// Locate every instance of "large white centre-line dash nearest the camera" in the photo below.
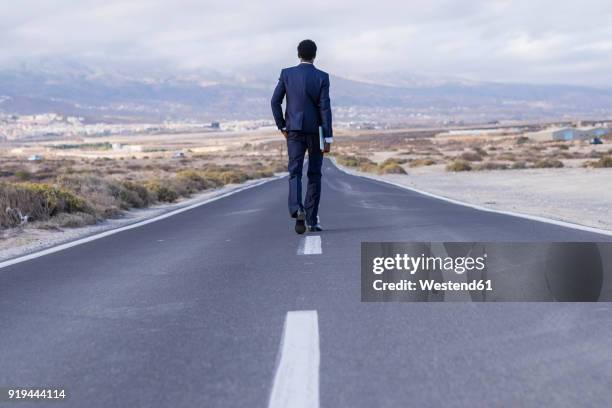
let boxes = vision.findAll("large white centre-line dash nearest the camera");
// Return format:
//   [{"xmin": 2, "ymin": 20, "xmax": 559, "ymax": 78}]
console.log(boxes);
[{"xmin": 268, "ymin": 310, "xmax": 321, "ymax": 408}]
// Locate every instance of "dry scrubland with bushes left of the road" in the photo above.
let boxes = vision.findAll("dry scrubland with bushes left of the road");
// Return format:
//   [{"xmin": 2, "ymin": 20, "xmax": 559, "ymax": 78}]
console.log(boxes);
[{"xmin": 0, "ymin": 132, "xmax": 286, "ymax": 249}]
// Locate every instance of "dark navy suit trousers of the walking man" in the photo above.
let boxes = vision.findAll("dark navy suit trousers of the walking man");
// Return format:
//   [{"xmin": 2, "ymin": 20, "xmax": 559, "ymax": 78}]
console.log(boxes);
[{"xmin": 287, "ymin": 131, "xmax": 323, "ymax": 225}]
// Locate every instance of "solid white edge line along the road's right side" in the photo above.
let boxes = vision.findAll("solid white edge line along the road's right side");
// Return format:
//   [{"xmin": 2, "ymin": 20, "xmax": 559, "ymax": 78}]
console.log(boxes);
[{"xmin": 330, "ymin": 158, "xmax": 612, "ymax": 237}]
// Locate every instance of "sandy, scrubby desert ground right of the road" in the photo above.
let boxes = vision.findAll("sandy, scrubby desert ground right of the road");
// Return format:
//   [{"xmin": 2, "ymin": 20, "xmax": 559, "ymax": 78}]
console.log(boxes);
[{"xmin": 335, "ymin": 130, "xmax": 612, "ymax": 230}]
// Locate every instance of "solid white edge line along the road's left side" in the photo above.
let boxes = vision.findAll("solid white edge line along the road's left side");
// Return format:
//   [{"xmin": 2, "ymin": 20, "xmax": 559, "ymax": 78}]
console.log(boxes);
[{"xmin": 0, "ymin": 175, "xmax": 286, "ymax": 269}]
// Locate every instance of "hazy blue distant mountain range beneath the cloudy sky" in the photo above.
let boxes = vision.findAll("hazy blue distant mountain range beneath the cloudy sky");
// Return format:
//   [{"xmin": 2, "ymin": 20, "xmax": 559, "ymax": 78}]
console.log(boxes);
[{"xmin": 0, "ymin": 60, "xmax": 612, "ymax": 122}]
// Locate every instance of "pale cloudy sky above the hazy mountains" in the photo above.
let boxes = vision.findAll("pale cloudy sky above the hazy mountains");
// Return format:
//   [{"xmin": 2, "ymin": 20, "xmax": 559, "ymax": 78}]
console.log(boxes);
[{"xmin": 0, "ymin": 0, "xmax": 612, "ymax": 86}]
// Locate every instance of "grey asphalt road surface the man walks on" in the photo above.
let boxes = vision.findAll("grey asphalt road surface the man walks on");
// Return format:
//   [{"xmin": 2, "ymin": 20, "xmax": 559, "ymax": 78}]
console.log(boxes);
[{"xmin": 0, "ymin": 161, "xmax": 612, "ymax": 407}]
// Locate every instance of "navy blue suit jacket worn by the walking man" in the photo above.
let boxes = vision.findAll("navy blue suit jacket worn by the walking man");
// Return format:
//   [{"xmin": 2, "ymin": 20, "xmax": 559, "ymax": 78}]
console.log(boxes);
[{"xmin": 271, "ymin": 63, "xmax": 333, "ymax": 138}]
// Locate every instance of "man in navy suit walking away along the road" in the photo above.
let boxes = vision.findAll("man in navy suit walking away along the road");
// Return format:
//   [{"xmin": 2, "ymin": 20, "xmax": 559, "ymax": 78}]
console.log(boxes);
[{"xmin": 271, "ymin": 40, "xmax": 333, "ymax": 234}]
